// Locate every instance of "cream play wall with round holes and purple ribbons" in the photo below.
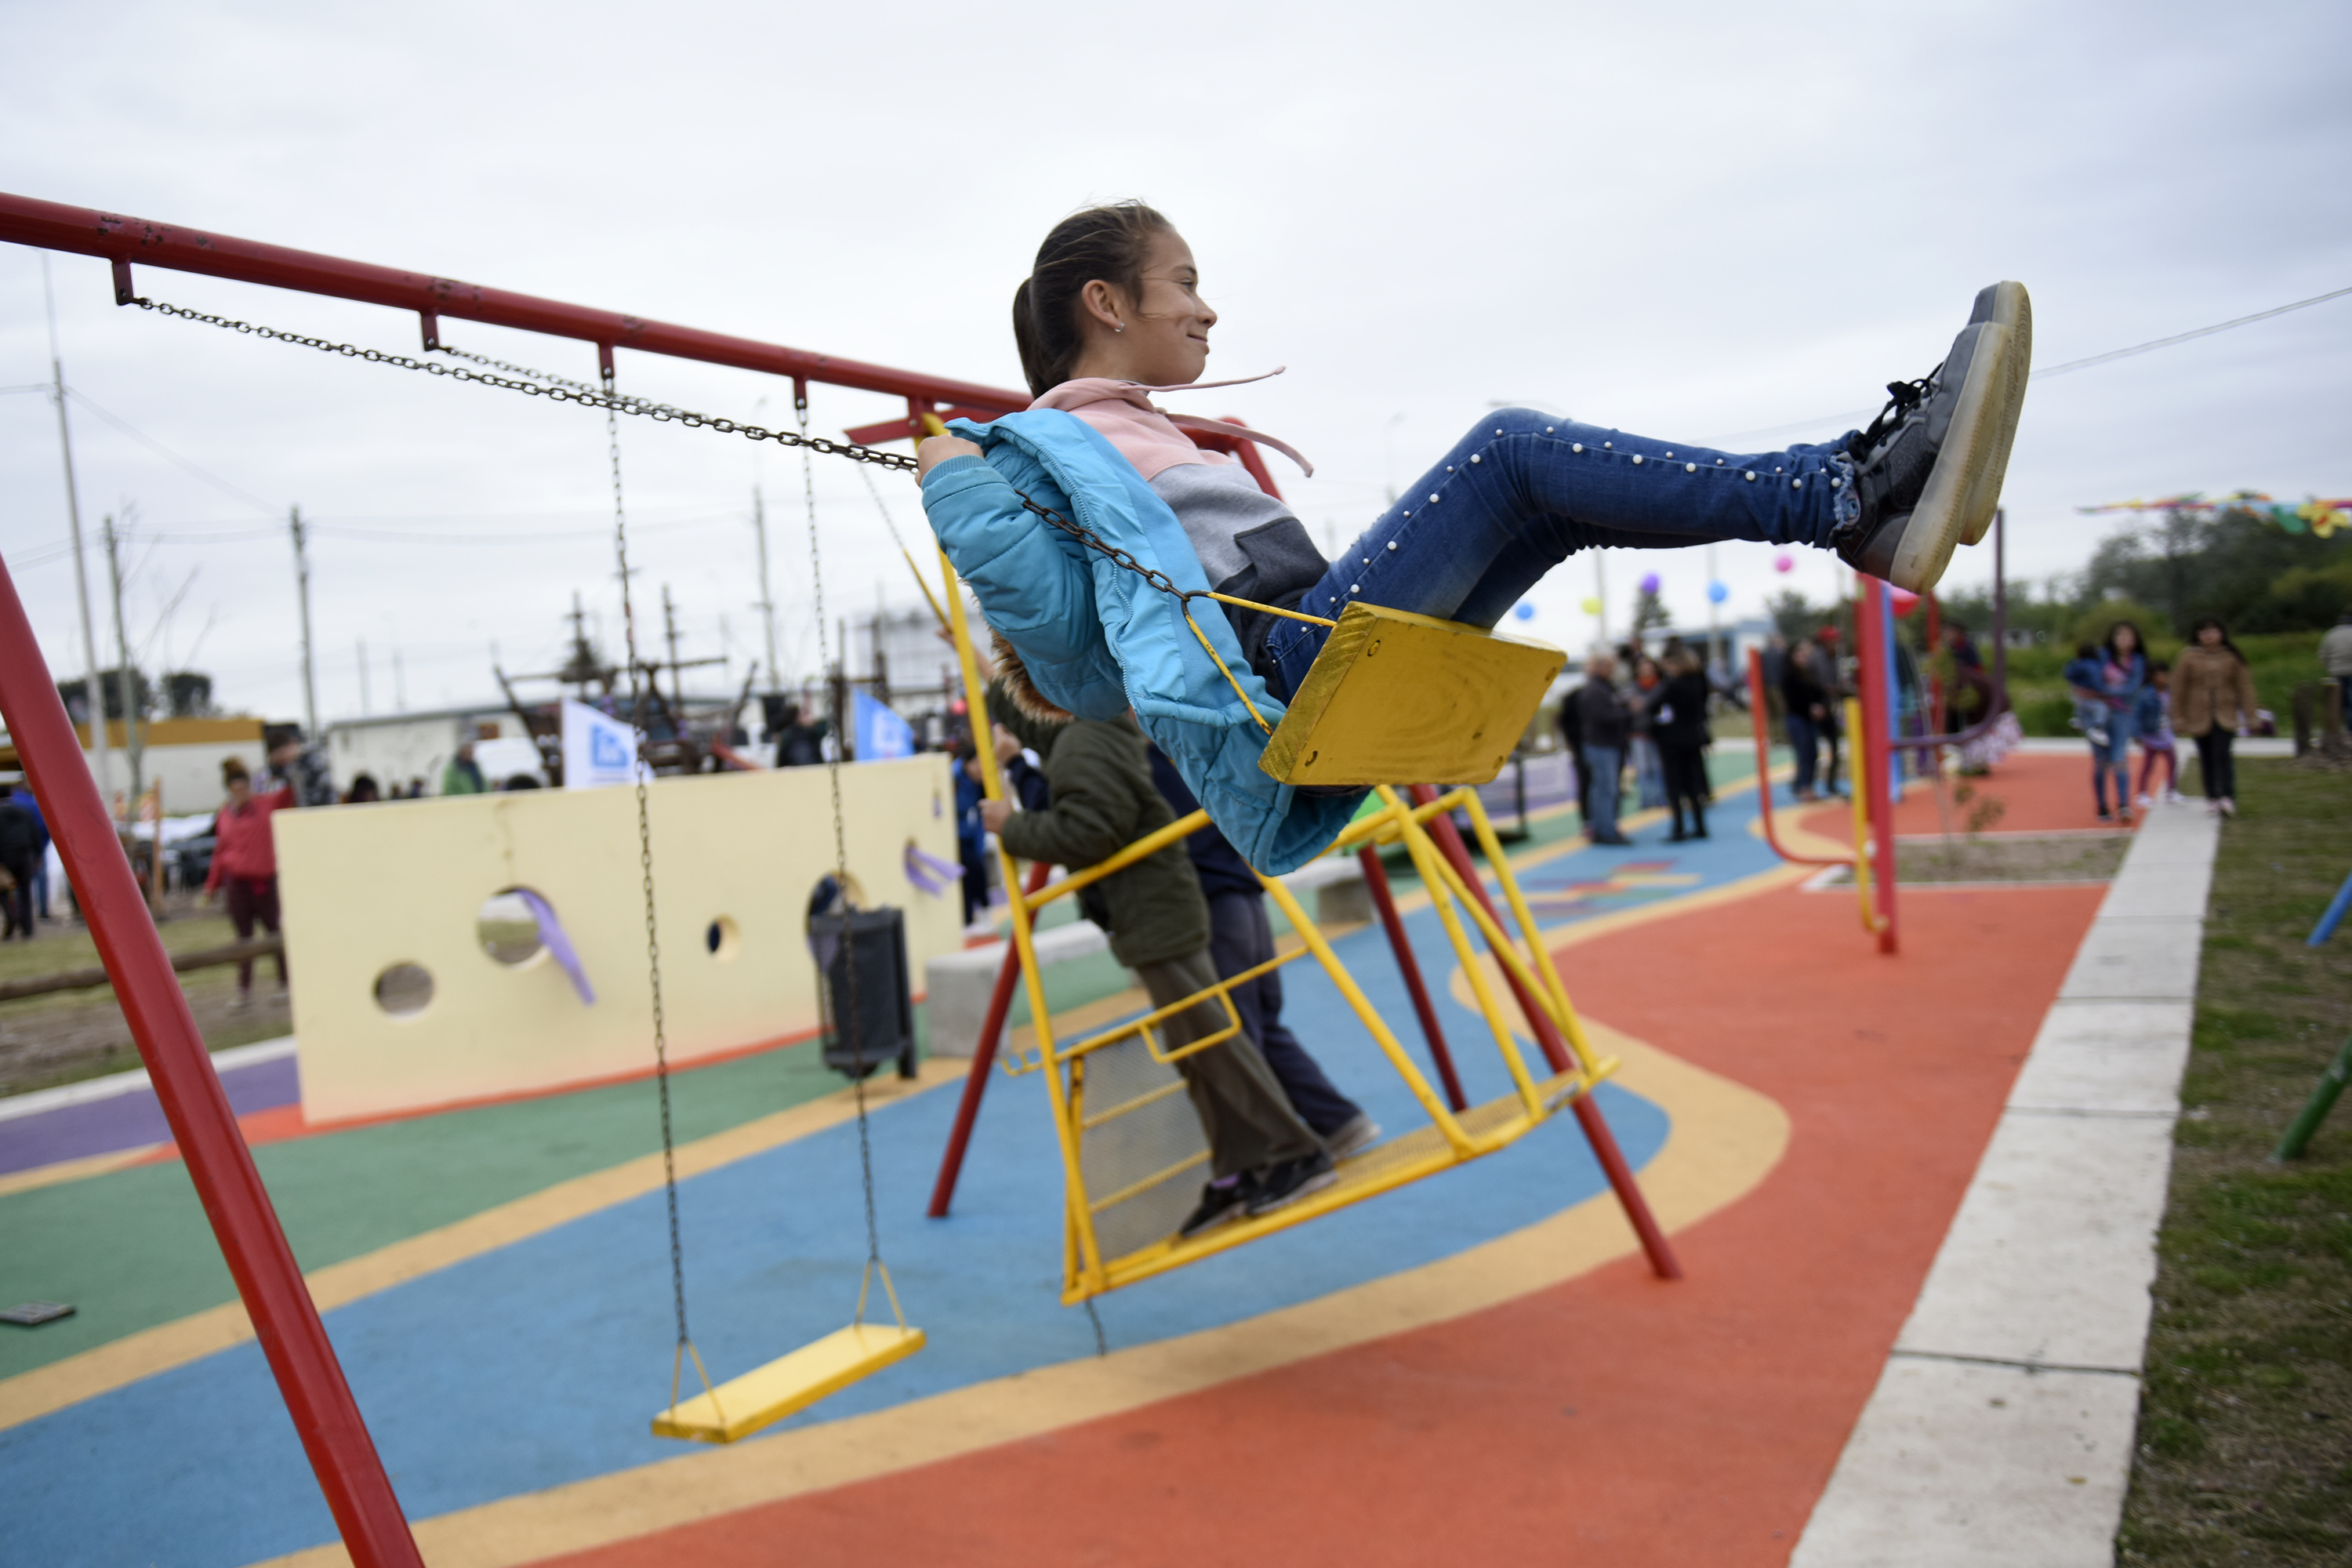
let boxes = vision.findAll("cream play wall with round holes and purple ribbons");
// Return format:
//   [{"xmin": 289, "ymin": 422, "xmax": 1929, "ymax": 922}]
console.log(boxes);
[{"xmin": 275, "ymin": 755, "xmax": 962, "ymax": 1123}]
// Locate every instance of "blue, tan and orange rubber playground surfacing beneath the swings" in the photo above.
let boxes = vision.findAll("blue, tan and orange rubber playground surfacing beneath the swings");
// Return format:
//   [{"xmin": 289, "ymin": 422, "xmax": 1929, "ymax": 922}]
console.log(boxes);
[{"xmin": 0, "ymin": 760, "xmax": 2098, "ymax": 1563}]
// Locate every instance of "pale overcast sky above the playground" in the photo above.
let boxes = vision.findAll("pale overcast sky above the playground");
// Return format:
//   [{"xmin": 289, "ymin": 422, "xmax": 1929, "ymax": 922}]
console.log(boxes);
[{"xmin": 0, "ymin": 0, "xmax": 2352, "ymax": 717}]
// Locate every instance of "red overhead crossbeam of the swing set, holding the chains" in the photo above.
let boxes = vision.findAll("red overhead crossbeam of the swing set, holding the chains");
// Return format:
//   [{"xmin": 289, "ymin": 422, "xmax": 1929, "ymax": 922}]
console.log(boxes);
[{"xmin": 0, "ymin": 191, "xmax": 1030, "ymax": 414}]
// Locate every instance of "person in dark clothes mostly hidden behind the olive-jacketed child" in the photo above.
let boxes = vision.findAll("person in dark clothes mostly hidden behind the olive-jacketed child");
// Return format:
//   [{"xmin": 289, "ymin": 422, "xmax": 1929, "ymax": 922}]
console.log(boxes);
[{"xmin": 1150, "ymin": 746, "xmax": 1381, "ymax": 1161}]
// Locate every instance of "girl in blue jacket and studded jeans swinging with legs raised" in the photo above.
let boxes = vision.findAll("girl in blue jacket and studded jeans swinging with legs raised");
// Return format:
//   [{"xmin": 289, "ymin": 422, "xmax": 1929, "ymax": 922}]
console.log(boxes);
[{"xmin": 917, "ymin": 202, "xmax": 2032, "ymax": 874}]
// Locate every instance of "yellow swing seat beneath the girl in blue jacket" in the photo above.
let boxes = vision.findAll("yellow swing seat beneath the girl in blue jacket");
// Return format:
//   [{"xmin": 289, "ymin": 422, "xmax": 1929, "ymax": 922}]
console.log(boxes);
[{"xmin": 1258, "ymin": 604, "xmax": 1569, "ymax": 785}]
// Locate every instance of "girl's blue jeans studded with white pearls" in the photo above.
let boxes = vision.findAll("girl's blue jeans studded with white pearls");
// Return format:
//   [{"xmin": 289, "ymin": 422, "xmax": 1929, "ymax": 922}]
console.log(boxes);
[{"xmin": 1261, "ymin": 409, "xmax": 1860, "ymax": 699}]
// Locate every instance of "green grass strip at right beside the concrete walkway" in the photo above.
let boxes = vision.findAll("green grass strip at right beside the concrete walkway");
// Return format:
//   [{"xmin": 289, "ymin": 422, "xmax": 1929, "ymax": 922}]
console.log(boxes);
[{"xmin": 2117, "ymin": 760, "xmax": 2352, "ymax": 1566}]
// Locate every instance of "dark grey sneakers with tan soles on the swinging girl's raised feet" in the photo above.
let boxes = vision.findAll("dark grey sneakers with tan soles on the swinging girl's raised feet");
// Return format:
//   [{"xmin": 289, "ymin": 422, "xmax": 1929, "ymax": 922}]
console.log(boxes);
[{"xmin": 1830, "ymin": 285, "xmax": 2032, "ymax": 593}]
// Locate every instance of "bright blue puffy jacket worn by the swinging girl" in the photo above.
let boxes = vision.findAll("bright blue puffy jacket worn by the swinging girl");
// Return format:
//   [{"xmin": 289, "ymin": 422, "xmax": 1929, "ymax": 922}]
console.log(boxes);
[{"xmin": 922, "ymin": 409, "xmax": 1362, "ymax": 877}]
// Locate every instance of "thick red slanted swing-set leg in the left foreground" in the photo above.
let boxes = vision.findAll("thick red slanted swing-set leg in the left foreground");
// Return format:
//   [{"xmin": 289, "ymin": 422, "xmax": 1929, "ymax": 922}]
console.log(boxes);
[{"xmin": 0, "ymin": 562, "xmax": 423, "ymax": 1568}]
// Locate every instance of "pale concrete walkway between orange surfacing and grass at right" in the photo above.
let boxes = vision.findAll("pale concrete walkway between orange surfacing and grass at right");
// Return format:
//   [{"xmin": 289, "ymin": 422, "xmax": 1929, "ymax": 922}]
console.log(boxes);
[{"xmin": 1790, "ymin": 804, "xmax": 2218, "ymax": 1568}]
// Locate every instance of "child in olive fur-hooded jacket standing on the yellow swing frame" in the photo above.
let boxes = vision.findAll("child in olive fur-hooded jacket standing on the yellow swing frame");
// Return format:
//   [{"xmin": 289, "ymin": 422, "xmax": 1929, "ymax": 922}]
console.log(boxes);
[{"xmin": 981, "ymin": 670, "xmax": 1334, "ymax": 1236}]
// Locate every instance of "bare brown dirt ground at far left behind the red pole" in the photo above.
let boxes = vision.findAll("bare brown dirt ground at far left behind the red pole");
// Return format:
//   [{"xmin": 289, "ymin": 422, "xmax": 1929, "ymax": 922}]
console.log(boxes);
[{"xmin": 0, "ymin": 900, "xmax": 294, "ymax": 1095}]
